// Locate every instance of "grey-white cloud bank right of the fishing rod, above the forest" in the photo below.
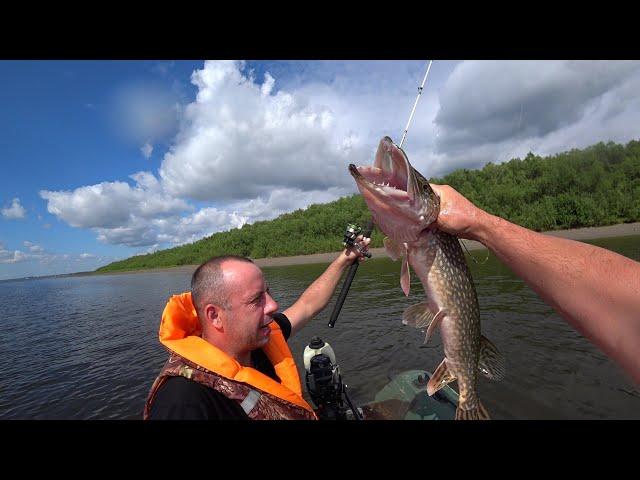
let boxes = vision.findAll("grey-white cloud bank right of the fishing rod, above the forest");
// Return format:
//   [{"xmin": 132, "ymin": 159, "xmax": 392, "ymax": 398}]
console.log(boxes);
[{"xmin": 434, "ymin": 60, "xmax": 640, "ymax": 173}]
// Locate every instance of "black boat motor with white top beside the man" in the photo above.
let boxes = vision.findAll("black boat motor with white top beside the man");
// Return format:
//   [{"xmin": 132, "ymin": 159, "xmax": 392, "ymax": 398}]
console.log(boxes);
[{"xmin": 304, "ymin": 337, "xmax": 363, "ymax": 420}]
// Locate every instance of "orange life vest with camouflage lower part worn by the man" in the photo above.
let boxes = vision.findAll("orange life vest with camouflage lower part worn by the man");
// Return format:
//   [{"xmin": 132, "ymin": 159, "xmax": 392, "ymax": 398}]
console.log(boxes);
[{"xmin": 145, "ymin": 292, "xmax": 316, "ymax": 418}]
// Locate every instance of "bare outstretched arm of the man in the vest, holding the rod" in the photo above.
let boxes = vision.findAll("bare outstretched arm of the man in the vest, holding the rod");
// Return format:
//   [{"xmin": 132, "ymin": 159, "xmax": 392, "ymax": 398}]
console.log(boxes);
[{"xmin": 283, "ymin": 236, "xmax": 371, "ymax": 336}]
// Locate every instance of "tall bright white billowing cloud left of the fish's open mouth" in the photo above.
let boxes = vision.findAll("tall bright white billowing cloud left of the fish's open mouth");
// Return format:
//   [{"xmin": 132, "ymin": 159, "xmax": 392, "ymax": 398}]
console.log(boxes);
[{"xmin": 160, "ymin": 61, "xmax": 370, "ymax": 200}]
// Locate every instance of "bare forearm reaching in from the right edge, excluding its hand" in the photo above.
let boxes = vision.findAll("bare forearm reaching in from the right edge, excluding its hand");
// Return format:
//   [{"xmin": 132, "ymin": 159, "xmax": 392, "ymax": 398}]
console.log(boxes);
[{"xmin": 473, "ymin": 214, "xmax": 640, "ymax": 383}]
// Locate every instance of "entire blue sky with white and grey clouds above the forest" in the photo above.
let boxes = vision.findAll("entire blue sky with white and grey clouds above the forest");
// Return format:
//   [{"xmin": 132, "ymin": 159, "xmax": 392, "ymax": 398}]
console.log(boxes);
[{"xmin": 0, "ymin": 60, "xmax": 640, "ymax": 280}]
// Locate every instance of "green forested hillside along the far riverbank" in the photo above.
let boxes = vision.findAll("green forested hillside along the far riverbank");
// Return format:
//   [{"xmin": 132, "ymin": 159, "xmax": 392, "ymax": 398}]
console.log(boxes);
[{"xmin": 97, "ymin": 141, "xmax": 640, "ymax": 272}]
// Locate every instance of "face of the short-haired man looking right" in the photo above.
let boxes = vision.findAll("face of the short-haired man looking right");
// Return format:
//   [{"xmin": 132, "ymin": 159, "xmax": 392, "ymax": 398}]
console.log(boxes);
[{"xmin": 221, "ymin": 261, "xmax": 278, "ymax": 352}]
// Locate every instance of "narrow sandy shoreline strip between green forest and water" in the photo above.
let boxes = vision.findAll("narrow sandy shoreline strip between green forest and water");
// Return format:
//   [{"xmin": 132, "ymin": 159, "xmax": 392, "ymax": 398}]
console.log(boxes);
[{"xmin": 63, "ymin": 222, "xmax": 640, "ymax": 278}]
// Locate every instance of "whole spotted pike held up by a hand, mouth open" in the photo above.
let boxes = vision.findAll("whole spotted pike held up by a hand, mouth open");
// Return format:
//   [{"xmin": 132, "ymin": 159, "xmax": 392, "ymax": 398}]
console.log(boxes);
[{"xmin": 349, "ymin": 137, "xmax": 505, "ymax": 420}]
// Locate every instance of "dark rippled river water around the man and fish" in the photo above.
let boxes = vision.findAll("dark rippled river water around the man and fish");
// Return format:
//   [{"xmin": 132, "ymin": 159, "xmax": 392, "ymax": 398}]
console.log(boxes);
[{"xmin": 0, "ymin": 236, "xmax": 640, "ymax": 419}]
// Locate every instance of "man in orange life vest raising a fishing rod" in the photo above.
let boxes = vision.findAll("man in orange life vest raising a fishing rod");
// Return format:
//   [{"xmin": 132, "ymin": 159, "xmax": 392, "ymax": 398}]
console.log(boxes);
[{"xmin": 143, "ymin": 236, "xmax": 370, "ymax": 420}]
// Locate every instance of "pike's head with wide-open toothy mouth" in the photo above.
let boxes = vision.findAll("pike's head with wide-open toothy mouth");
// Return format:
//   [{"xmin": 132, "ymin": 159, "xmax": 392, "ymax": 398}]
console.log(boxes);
[{"xmin": 349, "ymin": 137, "xmax": 440, "ymax": 242}]
